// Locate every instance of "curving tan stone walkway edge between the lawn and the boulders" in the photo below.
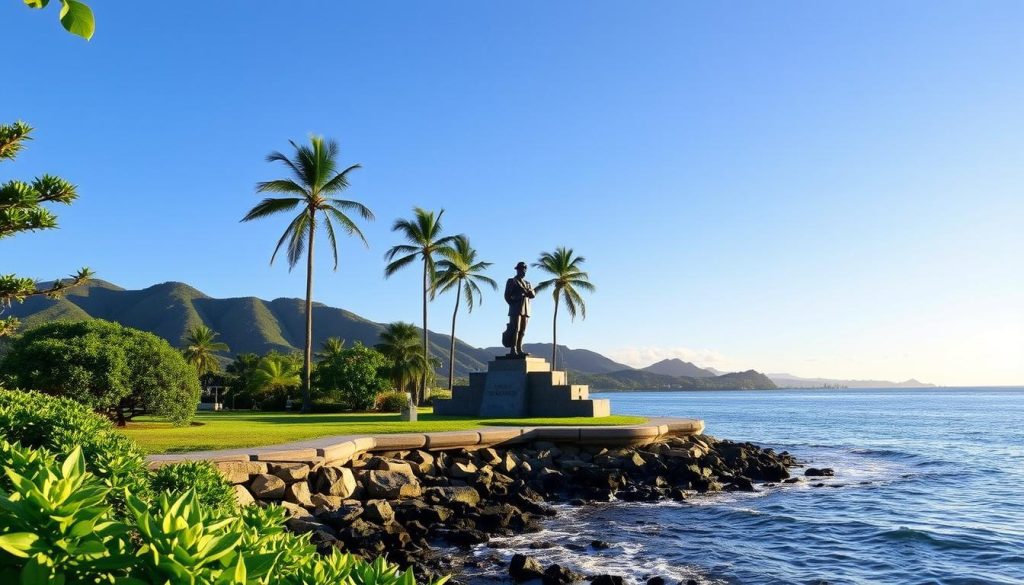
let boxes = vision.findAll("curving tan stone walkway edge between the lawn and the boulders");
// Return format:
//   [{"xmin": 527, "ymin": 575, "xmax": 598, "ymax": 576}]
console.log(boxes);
[{"xmin": 146, "ymin": 417, "xmax": 705, "ymax": 466}]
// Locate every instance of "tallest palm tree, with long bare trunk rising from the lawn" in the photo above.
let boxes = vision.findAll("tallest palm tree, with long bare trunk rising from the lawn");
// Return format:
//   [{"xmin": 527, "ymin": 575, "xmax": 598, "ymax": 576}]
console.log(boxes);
[{"xmin": 242, "ymin": 135, "xmax": 374, "ymax": 413}]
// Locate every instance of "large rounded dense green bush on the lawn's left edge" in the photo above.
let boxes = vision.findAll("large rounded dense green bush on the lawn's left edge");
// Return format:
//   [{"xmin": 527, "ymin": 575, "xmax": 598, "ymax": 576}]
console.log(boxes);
[{"xmin": 0, "ymin": 320, "xmax": 200, "ymax": 424}]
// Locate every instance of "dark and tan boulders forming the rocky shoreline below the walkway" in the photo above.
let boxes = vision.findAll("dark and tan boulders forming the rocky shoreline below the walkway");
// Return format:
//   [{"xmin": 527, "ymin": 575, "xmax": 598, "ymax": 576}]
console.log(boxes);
[{"xmin": 218, "ymin": 434, "xmax": 799, "ymax": 585}]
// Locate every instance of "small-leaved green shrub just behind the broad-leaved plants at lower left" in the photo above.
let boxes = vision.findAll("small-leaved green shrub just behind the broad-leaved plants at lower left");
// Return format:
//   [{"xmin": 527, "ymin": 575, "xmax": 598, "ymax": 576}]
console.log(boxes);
[{"xmin": 0, "ymin": 388, "xmax": 148, "ymax": 497}]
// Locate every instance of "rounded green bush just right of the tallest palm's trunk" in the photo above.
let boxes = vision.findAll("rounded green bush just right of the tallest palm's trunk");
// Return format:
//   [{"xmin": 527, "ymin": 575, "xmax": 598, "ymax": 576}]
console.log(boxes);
[{"xmin": 312, "ymin": 343, "xmax": 390, "ymax": 410}]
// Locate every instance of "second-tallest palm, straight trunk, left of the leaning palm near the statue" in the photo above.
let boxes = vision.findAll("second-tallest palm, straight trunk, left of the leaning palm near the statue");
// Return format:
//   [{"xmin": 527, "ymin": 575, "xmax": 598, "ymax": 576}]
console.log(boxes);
[{"xmin": 384, "ymin": 207, "xmax": 456, "ymax": 405}]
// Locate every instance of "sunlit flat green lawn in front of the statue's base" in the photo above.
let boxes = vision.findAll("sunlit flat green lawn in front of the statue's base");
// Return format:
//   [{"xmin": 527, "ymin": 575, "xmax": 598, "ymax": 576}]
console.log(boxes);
[{"xmin": 124, "ymin": 409, "xmax": 646, "ymax": 453}]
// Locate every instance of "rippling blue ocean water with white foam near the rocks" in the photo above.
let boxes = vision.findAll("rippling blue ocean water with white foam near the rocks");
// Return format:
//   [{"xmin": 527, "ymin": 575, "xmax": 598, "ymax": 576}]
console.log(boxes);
[{"xmin": 471, "ymin": 388, "xmax": 1024, "ymax": 585}]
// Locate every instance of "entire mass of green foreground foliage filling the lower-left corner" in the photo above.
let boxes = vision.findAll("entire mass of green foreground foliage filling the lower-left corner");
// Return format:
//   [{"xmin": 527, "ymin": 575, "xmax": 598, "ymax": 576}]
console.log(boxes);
[{"xmin": 0, "ymin": 389, "xmax": 446, "ymax": 585}]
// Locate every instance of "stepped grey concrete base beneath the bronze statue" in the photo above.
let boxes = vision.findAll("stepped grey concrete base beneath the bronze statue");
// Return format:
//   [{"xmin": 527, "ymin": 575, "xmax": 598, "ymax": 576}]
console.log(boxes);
[{"xmin": 434, "ymin": 358, "xmax": 611, "ymax": 418}]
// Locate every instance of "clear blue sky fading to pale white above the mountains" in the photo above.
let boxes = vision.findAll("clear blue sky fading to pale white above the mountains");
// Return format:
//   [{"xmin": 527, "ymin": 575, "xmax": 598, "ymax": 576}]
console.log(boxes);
[{"xmin": 0, "ymin": 0, "xmax": 1024, "ymax": 385}]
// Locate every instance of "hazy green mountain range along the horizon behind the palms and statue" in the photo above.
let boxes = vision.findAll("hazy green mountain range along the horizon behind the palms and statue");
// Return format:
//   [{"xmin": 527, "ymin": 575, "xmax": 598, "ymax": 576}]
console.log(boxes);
[{"xmin": 5, "ymin": 280, "xmax": 929, "ymax": 389}]
